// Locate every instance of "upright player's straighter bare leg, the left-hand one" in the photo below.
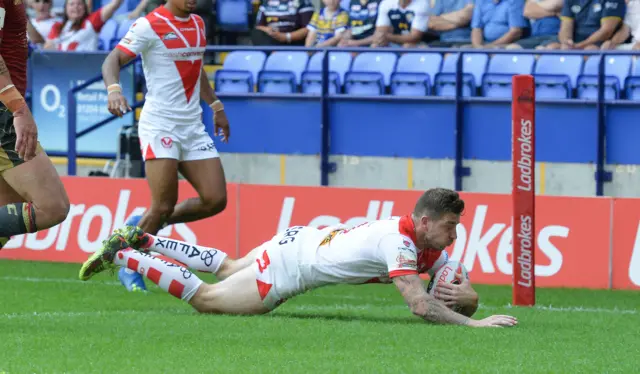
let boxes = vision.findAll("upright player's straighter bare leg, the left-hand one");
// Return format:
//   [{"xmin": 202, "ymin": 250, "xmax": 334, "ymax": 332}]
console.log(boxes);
[{"xmin": 138, "ymin": 158, "xmax": 178, "ymax": 234}]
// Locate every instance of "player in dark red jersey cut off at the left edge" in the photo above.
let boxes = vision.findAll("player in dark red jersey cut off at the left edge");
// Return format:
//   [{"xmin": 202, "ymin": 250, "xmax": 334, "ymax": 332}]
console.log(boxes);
[{"xmin": 0, "ymin": 0, "xmax": 69, "ymax": 248}]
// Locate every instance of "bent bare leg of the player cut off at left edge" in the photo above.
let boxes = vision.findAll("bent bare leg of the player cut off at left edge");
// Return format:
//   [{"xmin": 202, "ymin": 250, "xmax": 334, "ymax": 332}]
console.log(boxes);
[{"xmin": 0, "ymin": 150, "xmax": 69, "ymax": 245}]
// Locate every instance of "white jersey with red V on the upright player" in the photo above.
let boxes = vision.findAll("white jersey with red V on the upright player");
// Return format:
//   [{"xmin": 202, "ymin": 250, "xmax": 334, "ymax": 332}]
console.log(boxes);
[{"xmin": 116, "ymin": 5, "xmax": 207, "ymax": 131}]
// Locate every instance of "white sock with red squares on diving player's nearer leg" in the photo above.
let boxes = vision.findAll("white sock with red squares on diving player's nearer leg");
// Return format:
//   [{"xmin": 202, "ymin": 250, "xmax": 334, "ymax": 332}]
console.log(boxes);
[{"xmin": 113, "ymin": 248, "xmax": 204, "ymax": 302}]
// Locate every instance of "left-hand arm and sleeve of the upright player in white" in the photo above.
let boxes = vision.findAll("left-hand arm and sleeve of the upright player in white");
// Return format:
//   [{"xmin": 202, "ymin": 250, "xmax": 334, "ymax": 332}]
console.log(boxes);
[{"xmin": 102, "ymin": 18, "xmax": 153, "ymax": 117}]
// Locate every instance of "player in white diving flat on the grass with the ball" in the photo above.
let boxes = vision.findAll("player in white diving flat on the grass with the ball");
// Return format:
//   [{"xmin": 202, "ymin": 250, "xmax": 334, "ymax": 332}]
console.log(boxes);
[{"xmin": 80, "ymin": 188, "xmax": 517, "ymax": 327}]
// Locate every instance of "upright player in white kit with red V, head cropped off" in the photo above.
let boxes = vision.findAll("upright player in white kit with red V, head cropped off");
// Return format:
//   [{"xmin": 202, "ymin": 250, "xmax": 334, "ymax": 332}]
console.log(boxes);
[{"xmin": 102, "ymin": 0, "xmax": 230, "ymax": 290}]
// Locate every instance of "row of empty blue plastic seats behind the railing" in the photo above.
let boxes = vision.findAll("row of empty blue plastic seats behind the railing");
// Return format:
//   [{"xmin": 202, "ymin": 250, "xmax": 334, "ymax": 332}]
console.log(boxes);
[{"xmin": 213, "ymin": 51, "xmax": 640, "ymax": 100}]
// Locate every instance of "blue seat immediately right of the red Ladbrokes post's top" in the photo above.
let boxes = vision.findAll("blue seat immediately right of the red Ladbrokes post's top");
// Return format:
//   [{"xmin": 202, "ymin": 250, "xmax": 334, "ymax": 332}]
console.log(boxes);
[{"xmin": 533, "ymin": 55, "xmax": 584, "ymax": 99}]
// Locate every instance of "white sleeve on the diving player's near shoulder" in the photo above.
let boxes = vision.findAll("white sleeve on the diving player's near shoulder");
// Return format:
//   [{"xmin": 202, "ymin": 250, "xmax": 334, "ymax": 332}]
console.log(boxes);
[{"xmin": 378, "ymin": 234, "xmax": 418, "ymax": 279}]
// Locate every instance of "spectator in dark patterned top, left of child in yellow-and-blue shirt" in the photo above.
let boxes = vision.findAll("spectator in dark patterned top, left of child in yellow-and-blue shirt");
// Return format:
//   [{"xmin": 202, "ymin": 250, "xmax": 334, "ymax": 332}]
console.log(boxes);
[{"xmin": 251, "ymin": 0, "xmax": 314, "ymax": 46}]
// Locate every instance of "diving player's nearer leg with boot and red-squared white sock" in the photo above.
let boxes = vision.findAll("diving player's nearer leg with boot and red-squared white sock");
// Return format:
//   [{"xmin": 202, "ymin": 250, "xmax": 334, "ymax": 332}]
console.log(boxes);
[{"xmin": 80, "ymin": 232, "xmax": 269, "ymax": 314}]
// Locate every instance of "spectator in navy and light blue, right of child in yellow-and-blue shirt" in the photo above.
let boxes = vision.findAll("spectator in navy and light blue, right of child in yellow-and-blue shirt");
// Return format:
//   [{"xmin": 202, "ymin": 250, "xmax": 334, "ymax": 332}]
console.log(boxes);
[{"xmin": 338, "ymin": 0, "xmax": 380, "ymax": 47}]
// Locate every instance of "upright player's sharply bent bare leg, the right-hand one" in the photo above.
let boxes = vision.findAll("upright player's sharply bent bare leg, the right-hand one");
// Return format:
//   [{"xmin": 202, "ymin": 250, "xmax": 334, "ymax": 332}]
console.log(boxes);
[{"xmin": 168, "ymin": 158, "xmax": 227, "ymax": 224}]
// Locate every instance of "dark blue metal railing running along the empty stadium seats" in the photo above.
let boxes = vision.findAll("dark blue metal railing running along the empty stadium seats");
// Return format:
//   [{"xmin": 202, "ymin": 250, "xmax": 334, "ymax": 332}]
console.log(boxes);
[{"xmin": 63, "ymin": 46, "xmax": 640, "ymax": 196}]
